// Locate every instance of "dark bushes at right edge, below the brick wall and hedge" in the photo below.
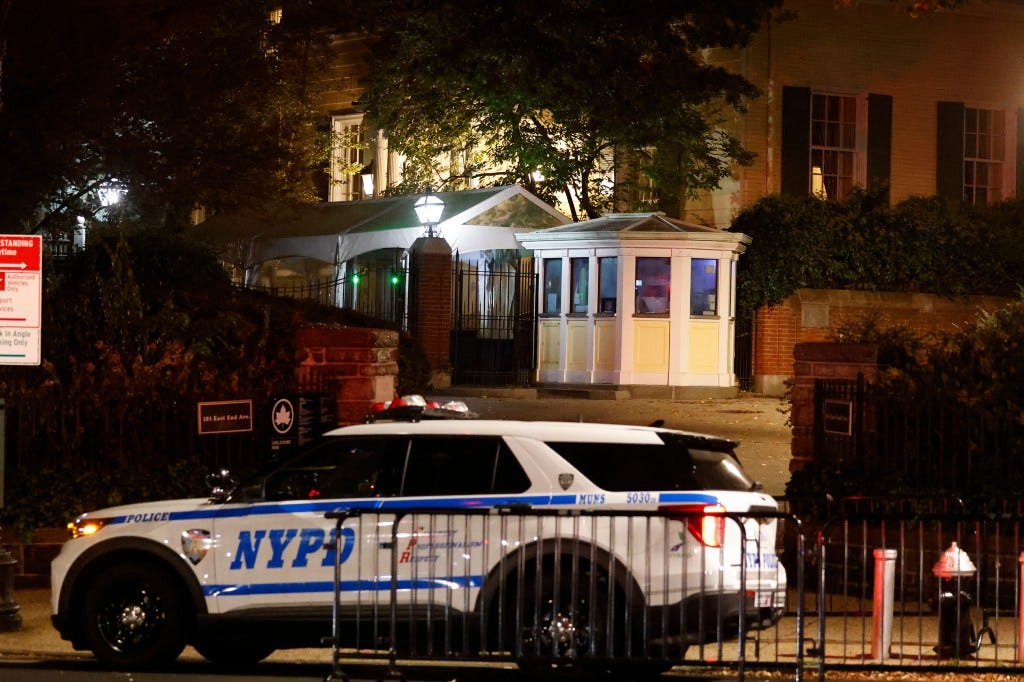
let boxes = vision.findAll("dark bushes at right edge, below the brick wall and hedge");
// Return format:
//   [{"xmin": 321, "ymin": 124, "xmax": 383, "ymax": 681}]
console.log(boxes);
[{"xmin": 786, "ymin": 296, "xmax": 1024, "ymax": 504}]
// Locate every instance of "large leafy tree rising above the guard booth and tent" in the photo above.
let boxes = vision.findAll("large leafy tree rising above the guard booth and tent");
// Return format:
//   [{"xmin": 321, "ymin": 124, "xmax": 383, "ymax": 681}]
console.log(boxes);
[{"xmin": 364, "ymin": 0, "xmax": 781, "ymax": 217}]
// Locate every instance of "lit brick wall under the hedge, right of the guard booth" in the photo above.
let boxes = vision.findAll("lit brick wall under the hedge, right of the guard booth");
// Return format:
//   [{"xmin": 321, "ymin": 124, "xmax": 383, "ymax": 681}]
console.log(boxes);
[{"xmin": 754, "ymin": 289, "xmax": 1010, "ymax": 395}]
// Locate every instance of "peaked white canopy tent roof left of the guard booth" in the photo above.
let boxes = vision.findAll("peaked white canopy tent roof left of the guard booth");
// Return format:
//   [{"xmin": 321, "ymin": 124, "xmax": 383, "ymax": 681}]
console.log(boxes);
[{"xmin": 197, "ymin": 185, "xmax": 568, "ymax": 262}]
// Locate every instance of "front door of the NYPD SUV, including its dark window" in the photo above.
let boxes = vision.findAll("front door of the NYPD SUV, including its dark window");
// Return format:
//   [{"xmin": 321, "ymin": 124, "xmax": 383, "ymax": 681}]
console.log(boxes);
[{"xmin": 209, "ymin": 435, "xmax": 408, "ymax": 634}]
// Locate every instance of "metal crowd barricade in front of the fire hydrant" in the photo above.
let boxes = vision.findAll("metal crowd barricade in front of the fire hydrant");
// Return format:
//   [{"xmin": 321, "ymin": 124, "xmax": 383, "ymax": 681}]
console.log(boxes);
[{"xmin": 808, "ymin": 498, "xmax": 1024, "ymax": 680}]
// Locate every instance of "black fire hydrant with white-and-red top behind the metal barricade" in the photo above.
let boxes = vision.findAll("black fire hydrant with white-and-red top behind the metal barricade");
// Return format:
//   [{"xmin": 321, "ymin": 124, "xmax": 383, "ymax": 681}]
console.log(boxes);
[{"xmin": 932, "ymin": 543, "xmax": 978, "ymax": 658}]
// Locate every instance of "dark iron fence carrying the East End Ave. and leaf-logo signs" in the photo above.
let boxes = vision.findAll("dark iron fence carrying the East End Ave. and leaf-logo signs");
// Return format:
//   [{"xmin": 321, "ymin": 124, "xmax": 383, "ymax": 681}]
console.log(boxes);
[{"xmin": 2, "ymin": 382, "xmax": 337, "ymax": 485}]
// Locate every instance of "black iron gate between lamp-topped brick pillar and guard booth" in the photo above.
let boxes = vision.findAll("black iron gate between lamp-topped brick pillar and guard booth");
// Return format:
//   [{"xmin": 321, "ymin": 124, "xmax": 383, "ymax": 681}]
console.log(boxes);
[{"xmin": 451, "ymin": 258, "xmax": 537, "ymax": 386}]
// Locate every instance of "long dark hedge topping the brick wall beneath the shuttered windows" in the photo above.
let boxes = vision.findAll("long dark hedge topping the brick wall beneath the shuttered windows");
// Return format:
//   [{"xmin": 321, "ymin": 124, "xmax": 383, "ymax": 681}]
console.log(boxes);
[{"xmin": 731, "ymin": 190, "xmax": 1024, "ymax": 316}]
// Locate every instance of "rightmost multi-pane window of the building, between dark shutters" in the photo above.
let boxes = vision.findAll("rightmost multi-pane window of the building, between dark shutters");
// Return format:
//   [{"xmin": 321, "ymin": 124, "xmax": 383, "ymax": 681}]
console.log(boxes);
[{"xmin": 964, "ymin": 108, "xmax": 1006, "ymax": 206}]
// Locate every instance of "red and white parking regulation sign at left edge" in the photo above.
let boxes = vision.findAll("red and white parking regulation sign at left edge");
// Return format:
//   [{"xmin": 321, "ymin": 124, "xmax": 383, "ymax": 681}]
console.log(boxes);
[{"xmin": 0, "ymin": 235, "xmax": 43, "ymax": 365}]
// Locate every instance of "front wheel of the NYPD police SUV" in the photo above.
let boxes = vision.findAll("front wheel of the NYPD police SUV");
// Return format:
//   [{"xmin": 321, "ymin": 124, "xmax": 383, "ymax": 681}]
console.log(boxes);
[{"xmin": 81, "ymin": 561, "xmax": 185, "ymax": 669}]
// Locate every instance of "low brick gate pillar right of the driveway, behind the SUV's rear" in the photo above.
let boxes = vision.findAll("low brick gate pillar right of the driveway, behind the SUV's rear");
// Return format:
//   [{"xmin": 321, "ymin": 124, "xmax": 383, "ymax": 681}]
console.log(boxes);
[{"xmin": 790, "ymin": 342, "xmax": 879, "ymax": 472}]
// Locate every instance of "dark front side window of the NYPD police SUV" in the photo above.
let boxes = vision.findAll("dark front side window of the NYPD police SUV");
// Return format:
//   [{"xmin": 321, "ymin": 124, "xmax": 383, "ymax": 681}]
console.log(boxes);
[{"xmin": 266, "ymin": 436, "xmax": 409, "ymax": 500}]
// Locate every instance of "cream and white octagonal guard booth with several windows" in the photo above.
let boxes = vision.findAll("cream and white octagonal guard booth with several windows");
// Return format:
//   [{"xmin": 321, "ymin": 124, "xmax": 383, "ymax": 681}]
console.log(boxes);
[{"xmin": 516, "ymin": 213, "xmax": 751, "ymax": 397}]
